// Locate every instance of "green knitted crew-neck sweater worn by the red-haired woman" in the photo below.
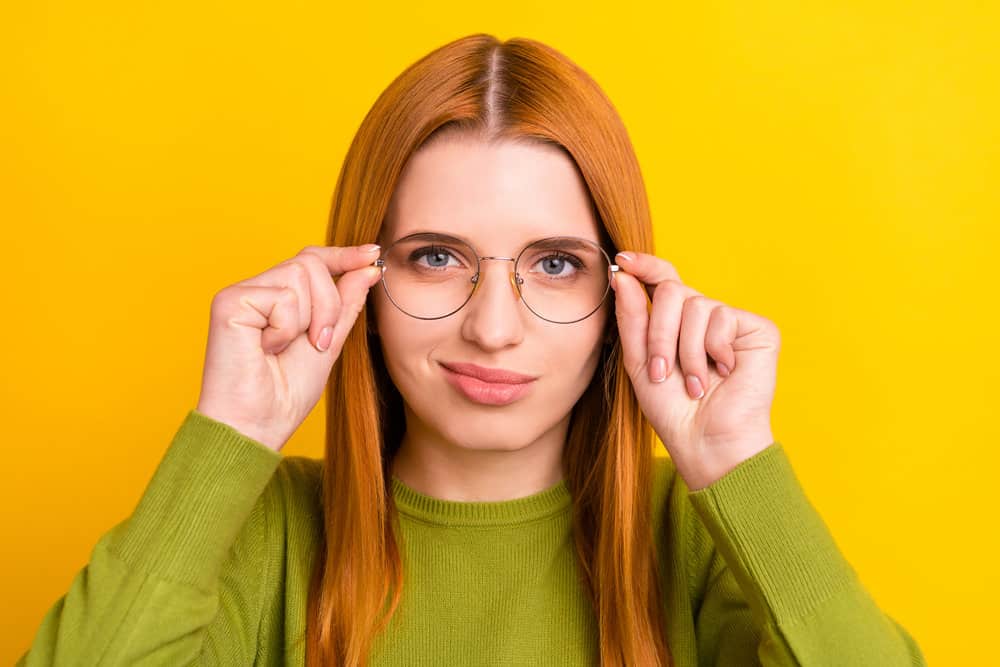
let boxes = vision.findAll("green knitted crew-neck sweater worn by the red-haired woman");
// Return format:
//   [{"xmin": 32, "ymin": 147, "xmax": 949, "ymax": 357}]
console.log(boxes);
[{"xmin": 18, "ymin": 410, "xmax": 926, "ymax": 667}]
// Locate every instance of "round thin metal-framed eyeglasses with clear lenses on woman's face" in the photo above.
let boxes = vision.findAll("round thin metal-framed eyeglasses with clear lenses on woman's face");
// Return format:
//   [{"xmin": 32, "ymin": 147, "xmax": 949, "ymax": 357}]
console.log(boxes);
[{"xmin": 375, "ymin": 232, "xmax": 619, "ymax": 324}]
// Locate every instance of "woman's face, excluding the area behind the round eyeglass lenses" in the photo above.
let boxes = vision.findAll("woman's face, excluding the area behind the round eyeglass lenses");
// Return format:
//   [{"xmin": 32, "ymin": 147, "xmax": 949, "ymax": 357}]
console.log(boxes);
[{"xmin": 372, "ymin": 135, "xmax": 611, "ymax": 460}]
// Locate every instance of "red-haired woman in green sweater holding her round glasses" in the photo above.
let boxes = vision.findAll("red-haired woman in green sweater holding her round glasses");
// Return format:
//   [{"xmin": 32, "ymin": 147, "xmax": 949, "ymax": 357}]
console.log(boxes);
[{"xmin": 22, "ymin": 34, "xmax": 924, "ymax": 666}]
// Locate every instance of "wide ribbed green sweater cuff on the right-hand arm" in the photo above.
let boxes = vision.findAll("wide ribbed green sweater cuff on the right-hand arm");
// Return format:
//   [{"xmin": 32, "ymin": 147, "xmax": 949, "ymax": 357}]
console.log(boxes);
[{"xmin": 688, "ymin": 442, "xmax": 857, "ymax": 625}]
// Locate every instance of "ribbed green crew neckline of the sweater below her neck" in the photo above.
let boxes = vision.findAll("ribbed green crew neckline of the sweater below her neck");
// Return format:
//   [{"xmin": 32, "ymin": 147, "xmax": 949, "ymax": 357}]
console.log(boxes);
[{"xmin": 392, "ymin": 475, "xmax": 573, "ymax": 526}]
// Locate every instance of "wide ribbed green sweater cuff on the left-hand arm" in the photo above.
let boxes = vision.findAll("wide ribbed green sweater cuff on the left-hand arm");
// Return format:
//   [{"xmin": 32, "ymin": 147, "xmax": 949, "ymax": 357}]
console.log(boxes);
[{"xmin": 111, "ymin": 410, "xmax": 283, "ymax": 590}]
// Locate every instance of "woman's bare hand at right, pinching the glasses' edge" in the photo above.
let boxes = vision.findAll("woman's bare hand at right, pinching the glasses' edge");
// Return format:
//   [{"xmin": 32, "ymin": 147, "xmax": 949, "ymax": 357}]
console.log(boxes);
[{"xmin": 612, "ymin": 251, "xmax": 781, "ymax": 491}]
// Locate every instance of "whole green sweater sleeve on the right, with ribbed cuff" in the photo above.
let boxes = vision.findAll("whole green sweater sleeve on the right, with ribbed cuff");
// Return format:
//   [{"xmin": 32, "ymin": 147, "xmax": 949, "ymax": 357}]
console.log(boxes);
[{"xmin": 688, "ymin": 442, "xmax": 927, "ymax": 667}]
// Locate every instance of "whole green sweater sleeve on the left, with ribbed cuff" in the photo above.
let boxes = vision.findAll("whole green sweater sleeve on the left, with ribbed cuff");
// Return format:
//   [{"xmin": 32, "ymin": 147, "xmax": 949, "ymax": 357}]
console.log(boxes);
[{"xmin": 17, "ymin": 410, "xmax": 283, "ymax": 667}]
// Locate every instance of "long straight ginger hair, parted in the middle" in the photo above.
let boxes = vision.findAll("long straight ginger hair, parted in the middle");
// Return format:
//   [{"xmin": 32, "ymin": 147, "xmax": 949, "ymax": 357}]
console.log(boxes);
[{"xmin": 304, "ymin": 33, "xmax": 672, "ymax": 667}]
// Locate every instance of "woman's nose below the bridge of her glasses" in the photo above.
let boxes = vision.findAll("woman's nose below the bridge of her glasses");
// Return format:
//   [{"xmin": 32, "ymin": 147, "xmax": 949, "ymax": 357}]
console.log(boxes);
[{"xmin": 459, "ymin": 260, "xmax": 526, "ymax": 350}]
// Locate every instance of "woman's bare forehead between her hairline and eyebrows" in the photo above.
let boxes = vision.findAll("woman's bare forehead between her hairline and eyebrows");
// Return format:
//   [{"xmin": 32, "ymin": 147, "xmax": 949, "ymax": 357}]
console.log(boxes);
[{"xmin": 380, "ymin": 135, "xmax": 600, "ymax": 252}]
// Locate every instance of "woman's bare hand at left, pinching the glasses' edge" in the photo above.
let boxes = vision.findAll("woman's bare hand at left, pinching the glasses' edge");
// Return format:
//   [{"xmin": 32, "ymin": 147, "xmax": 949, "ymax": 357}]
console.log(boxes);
[{"xmin": 197, "ymin": 244, "xmax": 382, "ymax": 451}]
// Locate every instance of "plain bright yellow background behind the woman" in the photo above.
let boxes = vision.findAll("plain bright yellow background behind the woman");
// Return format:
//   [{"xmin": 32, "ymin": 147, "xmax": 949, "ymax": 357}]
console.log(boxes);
[{"xmin": 0, "ymin": 0, "xmax": 1000, "ymax": 666}]
